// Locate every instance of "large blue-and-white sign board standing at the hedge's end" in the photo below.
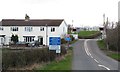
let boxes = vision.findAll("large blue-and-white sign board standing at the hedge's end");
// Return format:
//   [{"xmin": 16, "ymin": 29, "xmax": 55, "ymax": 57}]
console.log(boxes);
[{"xmin": 49, "ymin": 37, "xmax": 61, "ymax": 53}]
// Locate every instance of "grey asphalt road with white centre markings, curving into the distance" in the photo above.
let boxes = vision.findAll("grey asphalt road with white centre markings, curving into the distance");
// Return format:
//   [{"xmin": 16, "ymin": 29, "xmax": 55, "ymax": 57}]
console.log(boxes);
[{"xmin": 72, "ymin": 39, "xmax": 118, "ymax": 70}]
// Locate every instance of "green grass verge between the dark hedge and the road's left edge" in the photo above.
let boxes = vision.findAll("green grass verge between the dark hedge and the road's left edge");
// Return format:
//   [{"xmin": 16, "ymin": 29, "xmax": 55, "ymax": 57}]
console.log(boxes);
[{"xmin": 37, "ymin": 47, "xmax": 72, "ymax": 70}]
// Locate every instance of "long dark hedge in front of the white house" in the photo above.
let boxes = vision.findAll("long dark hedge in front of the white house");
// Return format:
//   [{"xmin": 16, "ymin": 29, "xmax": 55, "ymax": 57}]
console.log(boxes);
[{"xmin": 2, "ymin": 46, "xmax": 66, "ymax": 70}]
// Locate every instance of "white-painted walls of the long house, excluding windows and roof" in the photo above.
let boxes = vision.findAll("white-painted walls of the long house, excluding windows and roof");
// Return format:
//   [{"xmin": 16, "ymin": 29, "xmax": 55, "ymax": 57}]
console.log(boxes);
[{"xmin": 0, "ymin": 21, "xmax": 67, "ymax": 45}]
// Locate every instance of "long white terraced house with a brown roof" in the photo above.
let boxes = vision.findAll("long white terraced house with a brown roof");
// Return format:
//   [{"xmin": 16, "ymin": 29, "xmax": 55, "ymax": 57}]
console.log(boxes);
[{"xmin": 0, "ymin": 17, "xmax": 68, "ymax": 45}]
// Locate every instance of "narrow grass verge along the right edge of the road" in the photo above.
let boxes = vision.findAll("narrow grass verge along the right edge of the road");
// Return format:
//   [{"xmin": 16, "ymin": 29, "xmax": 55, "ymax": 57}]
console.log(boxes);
[{"xmin": 97, "ymin": 40, "xmax": 120, "ymax": 61}]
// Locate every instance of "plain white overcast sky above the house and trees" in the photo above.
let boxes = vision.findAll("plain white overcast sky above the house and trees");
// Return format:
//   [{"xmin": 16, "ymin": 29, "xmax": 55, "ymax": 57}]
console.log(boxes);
[{"xmin": 0, "ymin": 0, "xmax": 120, "ymax": 27}]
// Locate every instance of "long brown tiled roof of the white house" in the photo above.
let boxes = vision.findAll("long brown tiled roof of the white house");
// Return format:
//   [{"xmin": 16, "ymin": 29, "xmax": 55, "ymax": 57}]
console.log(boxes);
[{"xmin": 2, "ymin": 19, "xmax": 63, "ymax": 26}]
